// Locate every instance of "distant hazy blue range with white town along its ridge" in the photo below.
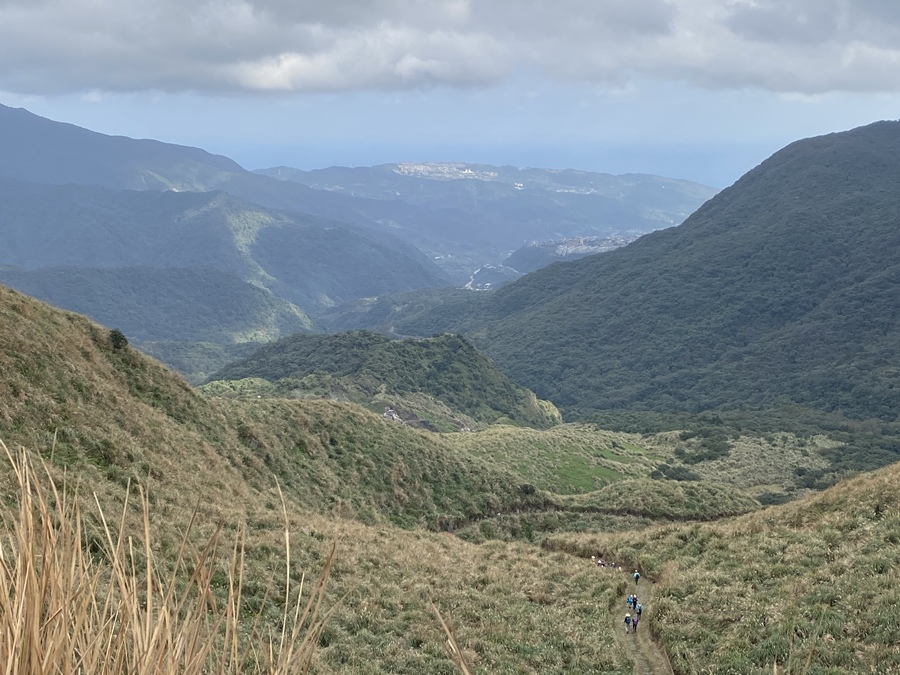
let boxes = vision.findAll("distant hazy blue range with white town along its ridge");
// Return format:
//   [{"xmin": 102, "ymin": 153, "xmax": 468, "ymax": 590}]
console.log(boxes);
[{"xmin": 256, "ymin": 162, "xmax": 716, "ymax": 283}]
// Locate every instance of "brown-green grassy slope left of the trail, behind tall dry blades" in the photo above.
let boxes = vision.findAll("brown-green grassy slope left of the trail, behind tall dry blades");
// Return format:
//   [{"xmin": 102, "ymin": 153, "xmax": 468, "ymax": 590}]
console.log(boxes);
[{"xmin": 0, "ymin": 288, "xmax": 630, "ymax": 674}]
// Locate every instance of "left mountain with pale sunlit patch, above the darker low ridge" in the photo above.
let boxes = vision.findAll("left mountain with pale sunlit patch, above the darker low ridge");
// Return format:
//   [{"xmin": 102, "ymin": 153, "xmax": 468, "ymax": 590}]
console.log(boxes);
[{"xmin": 0, "ymin": 178, "xmax": 446, "ymax": 311}]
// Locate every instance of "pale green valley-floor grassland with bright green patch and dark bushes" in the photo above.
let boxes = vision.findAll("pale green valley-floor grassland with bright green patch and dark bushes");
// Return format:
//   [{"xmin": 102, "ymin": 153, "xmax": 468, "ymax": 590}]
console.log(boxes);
[{"xmin": 446, "ymin": 423, "xmax": 842, "ymax": 504}]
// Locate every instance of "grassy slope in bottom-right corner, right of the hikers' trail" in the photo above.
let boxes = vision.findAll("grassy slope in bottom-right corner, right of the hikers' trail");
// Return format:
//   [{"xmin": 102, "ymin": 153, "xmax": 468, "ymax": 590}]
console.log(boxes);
[{"xmin": 549, "ymin": 465, "xmax": 900, "ymax": 675}]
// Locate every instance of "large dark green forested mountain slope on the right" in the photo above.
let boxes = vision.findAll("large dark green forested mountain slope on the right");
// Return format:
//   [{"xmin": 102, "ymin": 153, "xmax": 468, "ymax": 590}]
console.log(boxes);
[{"xmin": 384, "ymin": 122, "xmax": 900, "ymax": 419}]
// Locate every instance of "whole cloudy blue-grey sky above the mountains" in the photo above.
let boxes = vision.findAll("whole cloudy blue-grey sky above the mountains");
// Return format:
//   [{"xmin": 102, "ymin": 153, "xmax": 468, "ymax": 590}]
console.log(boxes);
[{"xmin": 0, "ymin": 0, "xmax": 900, "ymax": 187}]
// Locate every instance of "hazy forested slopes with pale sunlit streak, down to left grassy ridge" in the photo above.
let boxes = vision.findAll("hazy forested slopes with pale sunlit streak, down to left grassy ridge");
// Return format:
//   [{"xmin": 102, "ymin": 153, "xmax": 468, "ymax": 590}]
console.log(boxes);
[{"xmin": 0, "ymin": 178, "xmax": 447, "ymax": 380}]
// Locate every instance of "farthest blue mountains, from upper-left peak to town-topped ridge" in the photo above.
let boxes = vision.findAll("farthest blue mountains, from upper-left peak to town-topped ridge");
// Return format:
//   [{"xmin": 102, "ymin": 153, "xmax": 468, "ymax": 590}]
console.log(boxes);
[{"xmin": 0, "ymin": 106, "xmax": 716, "ymax": 278}]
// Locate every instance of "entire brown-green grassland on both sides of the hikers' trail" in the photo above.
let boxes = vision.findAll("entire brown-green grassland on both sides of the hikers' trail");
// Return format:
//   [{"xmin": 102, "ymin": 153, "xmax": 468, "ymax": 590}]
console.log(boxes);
[{"xmin": 0, "ymin": 274, "xmax": 900, "ymax": 675}]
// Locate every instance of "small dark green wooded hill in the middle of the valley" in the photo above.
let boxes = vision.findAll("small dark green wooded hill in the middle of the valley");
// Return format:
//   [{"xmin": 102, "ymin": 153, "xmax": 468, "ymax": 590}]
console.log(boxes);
[{"xmin": 205, "ymin": 331, "xmax": 558, "ymax": 430}]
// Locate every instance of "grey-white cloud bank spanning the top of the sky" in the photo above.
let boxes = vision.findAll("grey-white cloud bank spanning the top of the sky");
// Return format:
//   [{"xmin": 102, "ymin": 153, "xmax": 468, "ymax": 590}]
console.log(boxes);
[{"xmin": 0, "ymin": 0, "xmax": 900, "ymax": 94}]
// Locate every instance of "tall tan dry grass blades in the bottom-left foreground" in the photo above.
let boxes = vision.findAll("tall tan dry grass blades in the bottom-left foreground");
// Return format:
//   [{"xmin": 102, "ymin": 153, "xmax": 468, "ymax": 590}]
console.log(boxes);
[{"xmin": 0, "ymin": 443, "xmax": 334, "ymax": 675}]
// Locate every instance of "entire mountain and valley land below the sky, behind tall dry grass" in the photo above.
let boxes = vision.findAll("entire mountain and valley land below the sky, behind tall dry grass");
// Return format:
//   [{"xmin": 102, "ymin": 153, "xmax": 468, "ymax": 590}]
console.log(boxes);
[{"xmin": 0, "ymin": 108, "xmax": 900, "ymax": 675}]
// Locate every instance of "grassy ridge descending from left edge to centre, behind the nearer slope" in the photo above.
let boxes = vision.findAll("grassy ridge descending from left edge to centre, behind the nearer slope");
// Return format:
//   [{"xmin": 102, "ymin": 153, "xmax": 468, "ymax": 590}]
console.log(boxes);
[{"xmin": 0, "ymin": 287, "xmax": 540, "ymax": 526}]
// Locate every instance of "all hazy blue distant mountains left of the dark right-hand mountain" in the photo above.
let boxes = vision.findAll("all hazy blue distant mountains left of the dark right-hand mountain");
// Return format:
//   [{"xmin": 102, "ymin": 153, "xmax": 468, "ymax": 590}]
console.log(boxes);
[{"xmin": 0, "ymin": 106, "xmax": 715, "ymax": 381}]
